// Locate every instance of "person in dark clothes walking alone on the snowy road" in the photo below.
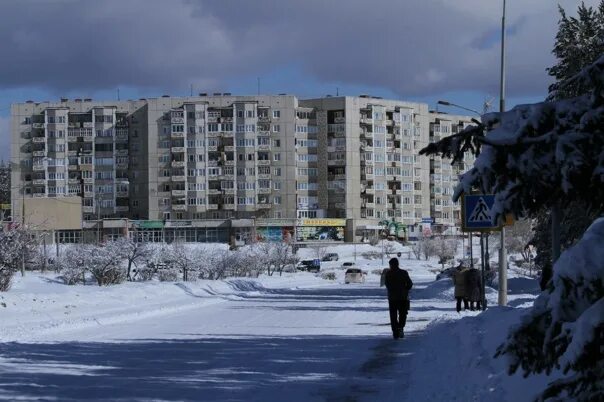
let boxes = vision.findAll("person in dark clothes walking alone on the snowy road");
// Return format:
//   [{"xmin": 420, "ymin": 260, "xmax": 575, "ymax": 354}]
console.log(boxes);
[{"xmin": 386, "ymin": 258, "xmax": 413, "ymax": 339}]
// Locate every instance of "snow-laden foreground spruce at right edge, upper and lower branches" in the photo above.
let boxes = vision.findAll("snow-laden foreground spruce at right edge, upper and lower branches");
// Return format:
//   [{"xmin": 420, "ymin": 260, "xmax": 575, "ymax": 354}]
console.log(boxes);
[{"xmin": 420, "ymin": 55, "xmax": 604, "ymax": 400}]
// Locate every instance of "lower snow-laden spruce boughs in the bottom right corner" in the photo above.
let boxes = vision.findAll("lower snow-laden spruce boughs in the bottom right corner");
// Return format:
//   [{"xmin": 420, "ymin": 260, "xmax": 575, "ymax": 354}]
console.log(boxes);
[{"xmin": 497, "ymin": 218, "xmax": 604, "ymax": 401}]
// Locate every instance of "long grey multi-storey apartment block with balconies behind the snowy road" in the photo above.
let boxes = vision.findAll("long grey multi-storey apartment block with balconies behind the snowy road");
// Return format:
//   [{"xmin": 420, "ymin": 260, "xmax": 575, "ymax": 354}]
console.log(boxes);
[{"xmin": 11, "ymin": 94, "xmax": 468, "ymax": 241}]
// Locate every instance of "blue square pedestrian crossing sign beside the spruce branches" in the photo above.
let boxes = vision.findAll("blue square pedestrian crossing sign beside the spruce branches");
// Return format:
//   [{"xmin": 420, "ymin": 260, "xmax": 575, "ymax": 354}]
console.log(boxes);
[{"xmin": 461, "ymin": 194, "xmax": 501, "ymax": 232}]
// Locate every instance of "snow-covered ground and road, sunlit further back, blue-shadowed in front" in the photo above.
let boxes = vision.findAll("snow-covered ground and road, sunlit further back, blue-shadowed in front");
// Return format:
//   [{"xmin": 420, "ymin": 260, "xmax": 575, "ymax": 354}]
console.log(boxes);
[{"xmin": 0, "ymin": 245, "xmax": 542, "ymax": 401}]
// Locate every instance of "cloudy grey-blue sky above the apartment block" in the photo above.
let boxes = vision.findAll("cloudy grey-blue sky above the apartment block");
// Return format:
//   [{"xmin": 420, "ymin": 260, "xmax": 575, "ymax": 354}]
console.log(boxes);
[{"xmin": 0, "ymin": 0, "xmax": 597, "ymax": 159}]
